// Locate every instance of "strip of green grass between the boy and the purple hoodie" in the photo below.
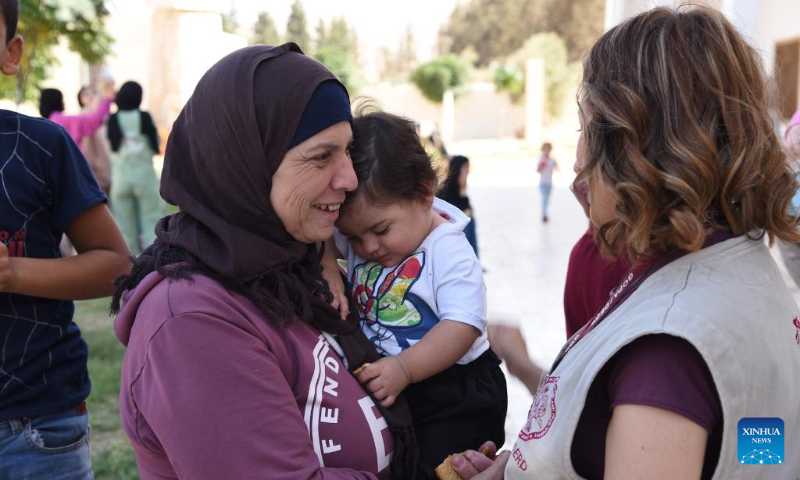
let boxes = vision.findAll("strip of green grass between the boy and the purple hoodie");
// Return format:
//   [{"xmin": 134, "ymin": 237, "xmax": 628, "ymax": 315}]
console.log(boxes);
[{"xmin": 75, "ymin": 298, "xmax": 139, "ymax": 480}]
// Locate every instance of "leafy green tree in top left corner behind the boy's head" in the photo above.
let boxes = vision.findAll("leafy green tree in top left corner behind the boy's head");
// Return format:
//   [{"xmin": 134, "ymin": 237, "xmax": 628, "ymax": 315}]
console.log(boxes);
[{"xmin": 0, "ymin": 0, "xmax": 113, "ymax": 103}]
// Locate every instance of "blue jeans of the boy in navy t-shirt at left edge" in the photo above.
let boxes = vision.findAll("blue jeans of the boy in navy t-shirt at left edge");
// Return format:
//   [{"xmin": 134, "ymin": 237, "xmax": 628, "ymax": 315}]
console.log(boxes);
[{"xmin": 0, "ymin": 405, "xmax": 93, "ymax": 480}]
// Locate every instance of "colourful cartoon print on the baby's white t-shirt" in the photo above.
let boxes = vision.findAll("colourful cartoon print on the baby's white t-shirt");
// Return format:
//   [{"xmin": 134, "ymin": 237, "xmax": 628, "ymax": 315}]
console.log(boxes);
[{"xmin": 350, "ymin": 252, "xmax": 439, "ymax": 353}]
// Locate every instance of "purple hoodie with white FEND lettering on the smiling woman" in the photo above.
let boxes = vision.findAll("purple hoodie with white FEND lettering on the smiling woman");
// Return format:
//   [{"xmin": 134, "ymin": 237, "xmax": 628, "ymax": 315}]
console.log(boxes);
[{"xmin": 114, "ymin": 273, "xmax": 394, "ymax": 480}]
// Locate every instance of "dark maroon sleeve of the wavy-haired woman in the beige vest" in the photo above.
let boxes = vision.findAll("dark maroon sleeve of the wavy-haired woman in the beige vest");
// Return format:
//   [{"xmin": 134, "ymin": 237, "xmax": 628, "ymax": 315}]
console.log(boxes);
[{"xmin": 608, "ymin": 334, "xmax": 722, "ymax": 434}]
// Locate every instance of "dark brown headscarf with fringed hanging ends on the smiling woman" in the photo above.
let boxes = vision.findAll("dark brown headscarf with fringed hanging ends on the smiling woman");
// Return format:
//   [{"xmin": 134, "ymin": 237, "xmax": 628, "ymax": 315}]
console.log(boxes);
[{"xmin": 142, "ymin": 43, "xmax": 431, "ymax": 479}]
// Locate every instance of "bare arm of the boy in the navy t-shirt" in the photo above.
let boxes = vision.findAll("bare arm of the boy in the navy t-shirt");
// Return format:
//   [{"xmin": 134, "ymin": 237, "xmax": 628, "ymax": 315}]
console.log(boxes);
[{"xmin": 0, "ymin": 203, "xmax": 130, "ymax": 300}]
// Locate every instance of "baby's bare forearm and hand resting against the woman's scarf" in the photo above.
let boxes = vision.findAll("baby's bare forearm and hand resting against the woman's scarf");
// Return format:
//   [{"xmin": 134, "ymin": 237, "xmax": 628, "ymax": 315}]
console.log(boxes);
[{"xmin": 358, "ymin": 320, "xmax": 480, "ymax": 407}]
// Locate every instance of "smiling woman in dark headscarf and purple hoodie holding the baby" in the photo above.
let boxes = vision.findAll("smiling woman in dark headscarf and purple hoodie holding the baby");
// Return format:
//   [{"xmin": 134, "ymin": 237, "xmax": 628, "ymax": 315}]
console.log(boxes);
[{"xmin": 112, "ymin": 43, "xmax": 428, "ymax": 480}]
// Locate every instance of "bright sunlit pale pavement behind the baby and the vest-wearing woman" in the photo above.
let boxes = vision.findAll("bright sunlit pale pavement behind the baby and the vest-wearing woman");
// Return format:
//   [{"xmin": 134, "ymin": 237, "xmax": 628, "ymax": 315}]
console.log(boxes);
[{"xmin": 469, "ymin": 182, "xmax": 800, "ymax": 448}]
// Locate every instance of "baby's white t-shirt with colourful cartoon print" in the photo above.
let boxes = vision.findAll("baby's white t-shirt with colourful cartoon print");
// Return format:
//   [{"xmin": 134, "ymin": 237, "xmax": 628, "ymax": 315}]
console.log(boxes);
[{"xmin": 334, "ymin": 198, "xmax": 489, "ymax": 365}]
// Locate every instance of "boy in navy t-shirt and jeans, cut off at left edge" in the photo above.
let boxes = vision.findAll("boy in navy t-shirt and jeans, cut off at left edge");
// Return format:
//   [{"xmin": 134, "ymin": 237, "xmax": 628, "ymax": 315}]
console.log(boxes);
[{"xmin": 0, "ymin": 0, "xmax": 130, "ymax": 480}]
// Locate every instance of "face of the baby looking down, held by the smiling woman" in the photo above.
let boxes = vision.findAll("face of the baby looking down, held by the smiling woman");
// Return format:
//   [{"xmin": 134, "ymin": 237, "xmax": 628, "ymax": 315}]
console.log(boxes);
[{"xmin": 336, "ymin": 195, "xmax": 435, "ymax": 267}]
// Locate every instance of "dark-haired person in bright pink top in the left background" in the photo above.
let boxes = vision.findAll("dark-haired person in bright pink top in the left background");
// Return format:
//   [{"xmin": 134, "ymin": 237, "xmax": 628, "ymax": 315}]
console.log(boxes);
[{"xmin": 39, "ymin": 77, "xmax": 114, "ymax": 151}]
